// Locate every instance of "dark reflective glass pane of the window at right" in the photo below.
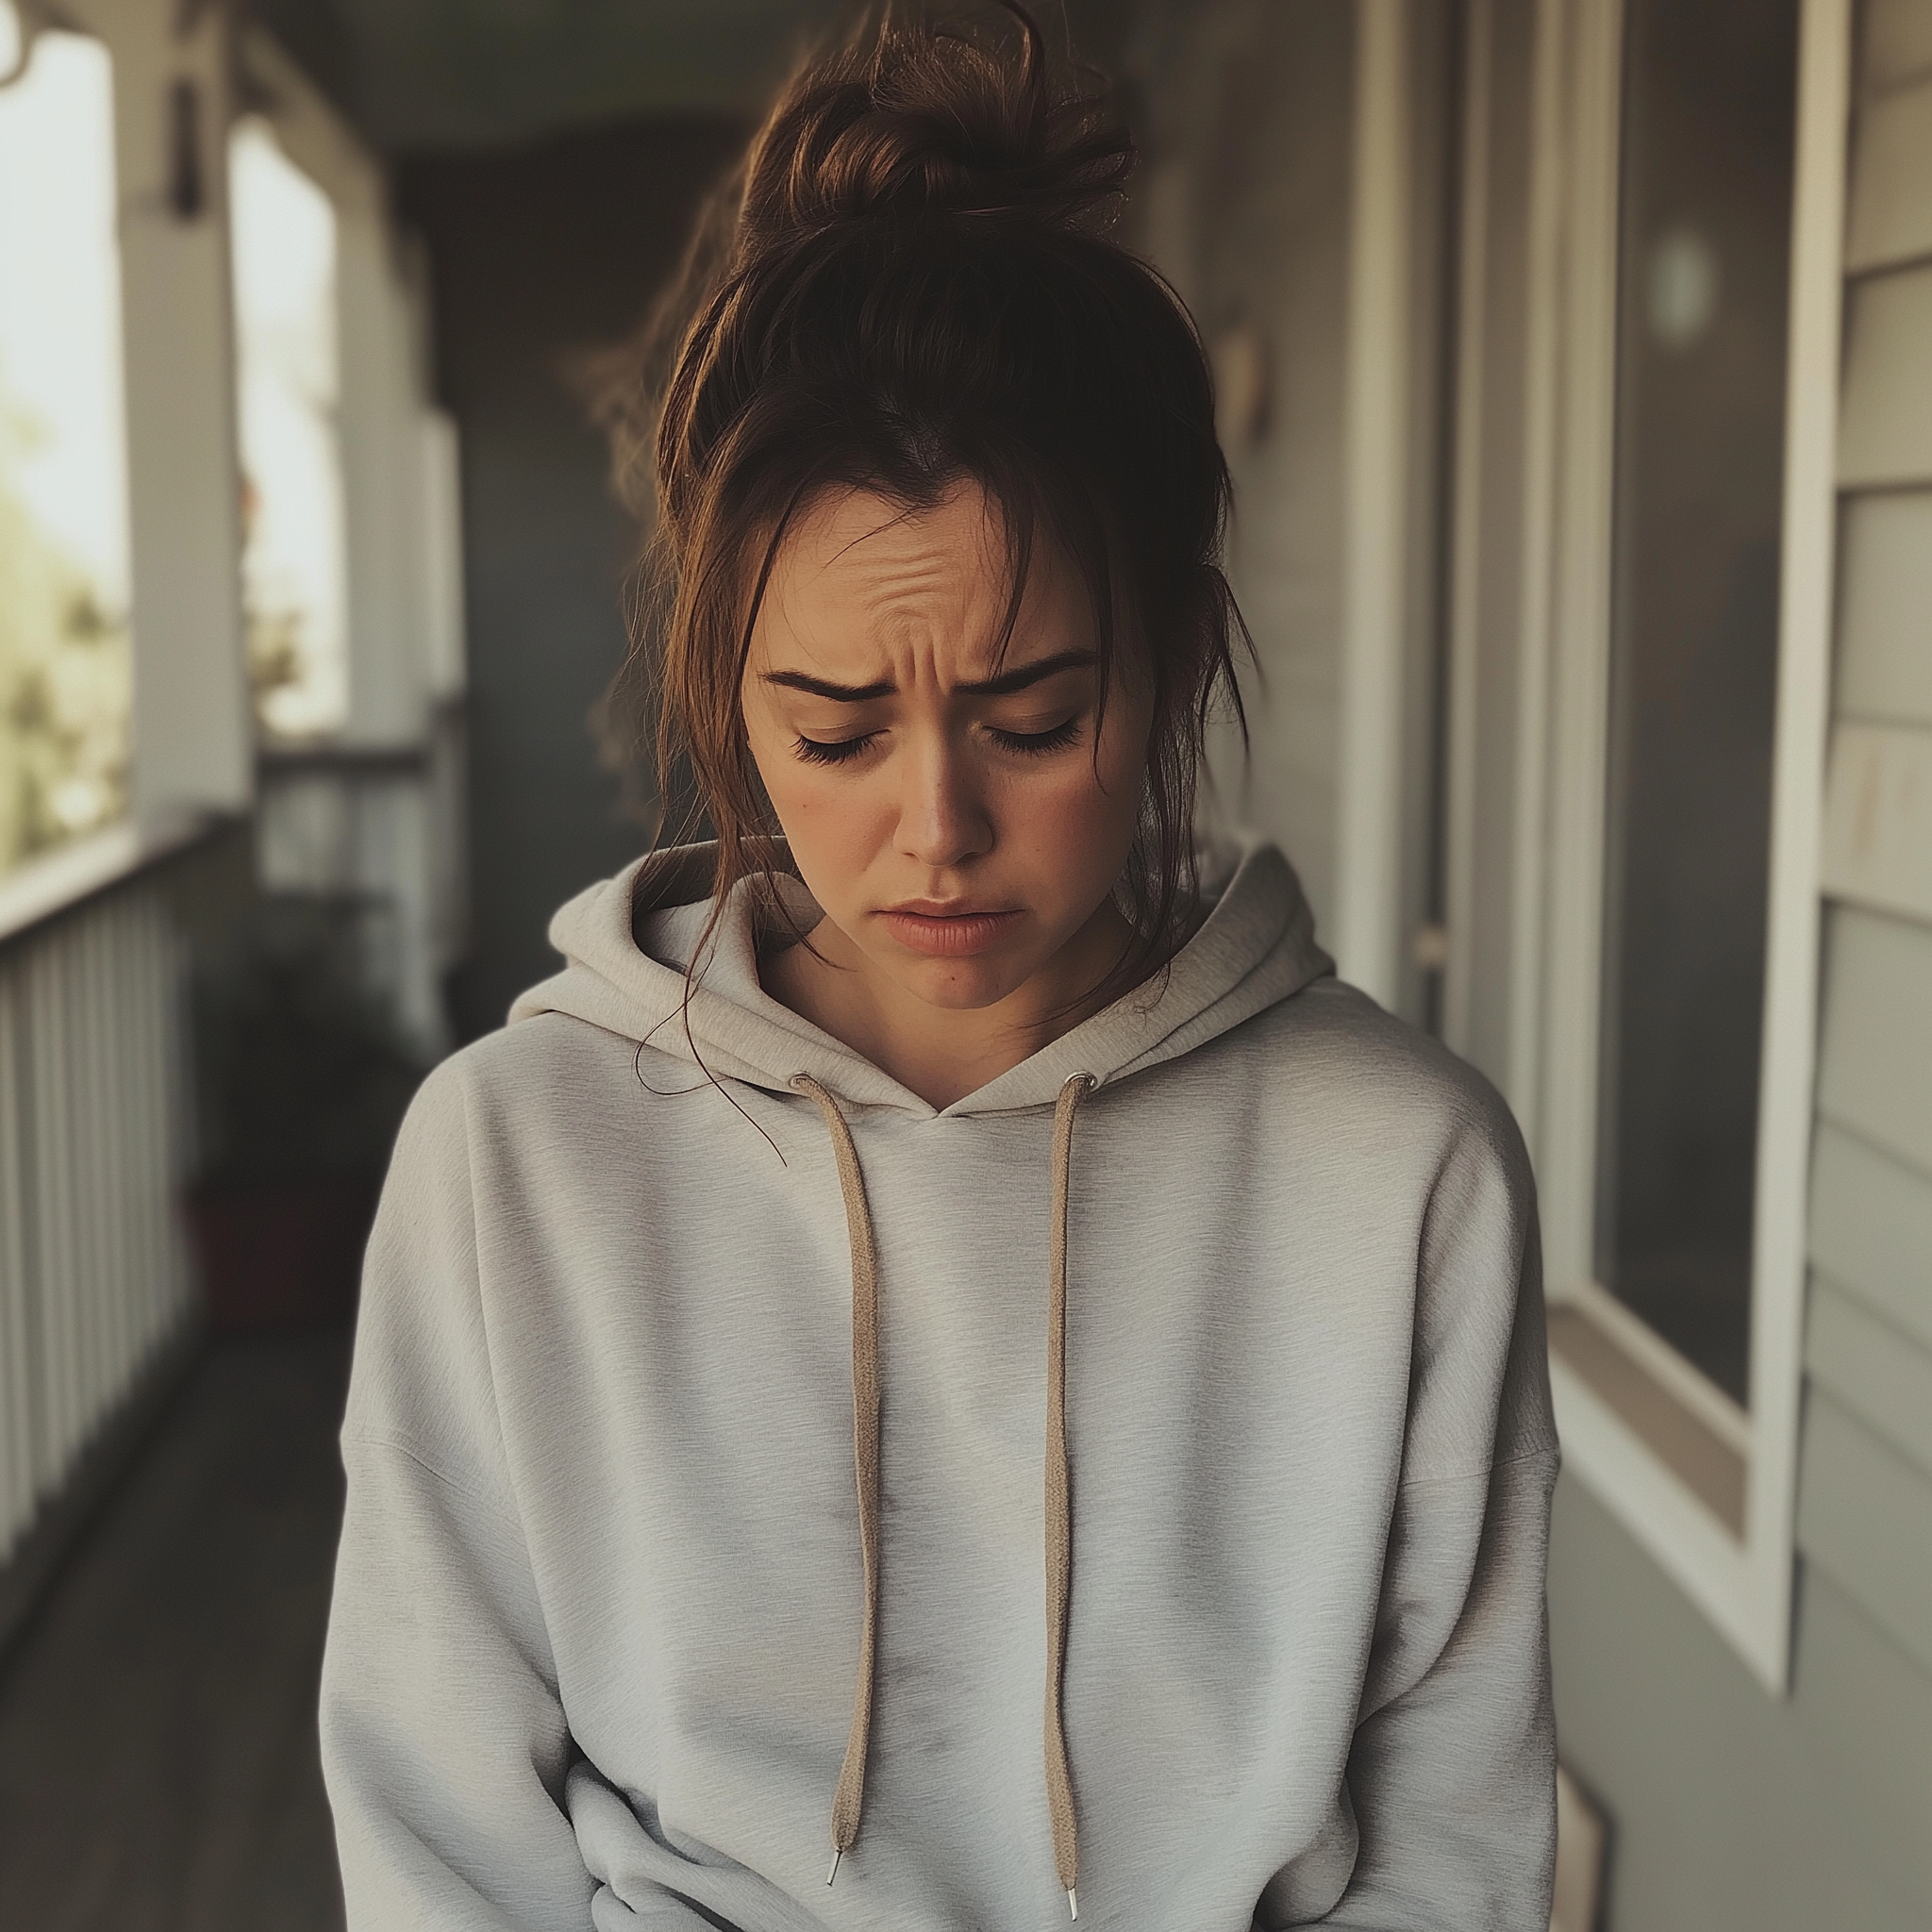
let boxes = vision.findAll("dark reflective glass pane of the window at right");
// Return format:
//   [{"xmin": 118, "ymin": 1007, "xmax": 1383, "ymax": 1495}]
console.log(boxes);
[{"xmin": 1596, "ymin": 0, "xmax": 1799, "ymax": 1405}]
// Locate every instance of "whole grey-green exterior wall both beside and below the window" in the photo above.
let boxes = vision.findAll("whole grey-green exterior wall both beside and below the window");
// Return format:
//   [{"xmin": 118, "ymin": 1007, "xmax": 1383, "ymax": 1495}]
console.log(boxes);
[{"xmin": 1552, "ymin": 0, "xmax": 1932, "ymax": 1932}]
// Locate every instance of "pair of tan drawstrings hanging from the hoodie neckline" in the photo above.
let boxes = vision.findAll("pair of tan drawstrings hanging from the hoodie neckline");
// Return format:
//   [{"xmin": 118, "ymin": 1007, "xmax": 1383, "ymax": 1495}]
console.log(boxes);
[{"xmin": 792, "ymin": 1074, "xmax": 1095, "ymax": 1919}]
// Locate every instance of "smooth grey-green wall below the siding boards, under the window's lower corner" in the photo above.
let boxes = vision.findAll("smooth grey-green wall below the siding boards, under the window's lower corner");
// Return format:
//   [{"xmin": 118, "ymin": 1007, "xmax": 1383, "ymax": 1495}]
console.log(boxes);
[{"xmin": 1549, "ymin": 1476, "xmax": 1932, "ymax": 1932}]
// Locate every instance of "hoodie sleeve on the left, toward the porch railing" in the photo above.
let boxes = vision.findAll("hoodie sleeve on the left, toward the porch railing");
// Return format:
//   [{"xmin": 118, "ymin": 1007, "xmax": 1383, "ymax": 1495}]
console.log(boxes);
[{"xmin": 321, "ymin": 1064, "xmax": 593, "ymax": 1932}]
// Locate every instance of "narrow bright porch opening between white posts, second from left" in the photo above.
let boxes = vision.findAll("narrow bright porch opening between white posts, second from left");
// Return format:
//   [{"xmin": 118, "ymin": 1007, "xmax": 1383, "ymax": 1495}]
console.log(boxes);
[{"xmin": 228, "ymin": 120, "xmax": 348, "ymax": 738}]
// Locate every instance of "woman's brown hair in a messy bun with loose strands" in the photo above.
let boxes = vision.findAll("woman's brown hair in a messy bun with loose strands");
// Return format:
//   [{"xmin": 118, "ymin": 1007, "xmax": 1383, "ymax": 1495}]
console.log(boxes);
[{"xmin": 607, "ymin": 0, "xmax": 1248, "ymax": 999}]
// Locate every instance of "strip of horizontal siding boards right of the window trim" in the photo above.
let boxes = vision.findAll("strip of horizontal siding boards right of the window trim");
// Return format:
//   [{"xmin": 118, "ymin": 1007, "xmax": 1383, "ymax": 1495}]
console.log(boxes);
[{"xmin": 1799, "ymin": 0, "xmax": 1932, "ymax": 1707}]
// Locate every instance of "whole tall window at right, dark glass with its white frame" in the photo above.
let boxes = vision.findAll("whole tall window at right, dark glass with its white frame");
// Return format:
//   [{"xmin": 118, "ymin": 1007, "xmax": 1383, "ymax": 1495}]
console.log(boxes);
[{"xmin": 1445, "ymin": 0, "xmax": 1851, "ymax": 1689}]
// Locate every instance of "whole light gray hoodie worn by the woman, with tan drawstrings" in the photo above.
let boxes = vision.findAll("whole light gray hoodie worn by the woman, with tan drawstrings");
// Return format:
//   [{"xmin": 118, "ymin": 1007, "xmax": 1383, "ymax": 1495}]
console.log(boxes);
[{"xmin": 323, "ymin": 846, "xmax": 1556, "ymax": 1932}]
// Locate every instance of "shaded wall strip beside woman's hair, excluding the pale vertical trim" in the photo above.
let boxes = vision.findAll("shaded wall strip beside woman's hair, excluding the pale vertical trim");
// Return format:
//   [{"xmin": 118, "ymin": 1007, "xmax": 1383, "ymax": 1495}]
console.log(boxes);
[{"xmin": 1128, "ymin": 0, "xmax": 1355, "ymax": 931}]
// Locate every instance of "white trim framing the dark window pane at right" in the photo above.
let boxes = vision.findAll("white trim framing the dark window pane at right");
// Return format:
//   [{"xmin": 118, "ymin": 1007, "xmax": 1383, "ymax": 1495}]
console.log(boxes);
[{"xmin": 1464, "ymin": 0, "xmax": 1851, "ymax": 1694}]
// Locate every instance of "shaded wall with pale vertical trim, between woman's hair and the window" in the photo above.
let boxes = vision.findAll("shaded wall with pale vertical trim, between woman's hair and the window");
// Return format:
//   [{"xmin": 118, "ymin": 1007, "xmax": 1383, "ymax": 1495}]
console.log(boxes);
[{"xmin": 1119, "ymin": 0, "xmax": 1455, "ymax": 1022}]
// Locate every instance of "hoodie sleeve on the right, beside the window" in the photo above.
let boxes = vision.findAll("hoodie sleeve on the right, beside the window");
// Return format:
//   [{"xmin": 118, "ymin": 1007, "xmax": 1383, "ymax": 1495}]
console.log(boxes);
[{"xmin": 1322, "ymin": 1117, "xmax": 1557, "ymax": 1932}]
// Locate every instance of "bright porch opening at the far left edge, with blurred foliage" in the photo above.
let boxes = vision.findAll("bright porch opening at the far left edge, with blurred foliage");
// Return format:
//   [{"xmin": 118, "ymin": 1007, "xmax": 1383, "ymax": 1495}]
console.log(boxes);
[{"xmin": 0, "ymin": 6, "xmax": 131, "ymax": 872}]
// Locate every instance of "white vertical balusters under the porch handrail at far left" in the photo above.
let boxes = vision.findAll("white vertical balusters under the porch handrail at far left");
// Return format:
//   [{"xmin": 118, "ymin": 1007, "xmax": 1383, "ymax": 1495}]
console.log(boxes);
[{"xmin": 0, "ymin": 830, "xmax": 195, "ymax": 1563}]
